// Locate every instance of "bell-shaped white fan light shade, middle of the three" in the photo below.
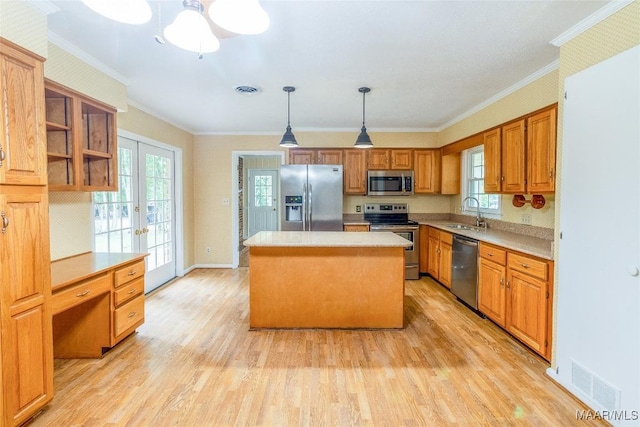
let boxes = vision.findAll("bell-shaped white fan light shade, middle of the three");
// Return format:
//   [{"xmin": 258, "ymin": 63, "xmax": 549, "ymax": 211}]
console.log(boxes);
[{"xmin": 164, "ymin": 0, "xmax": 220, "ymax": 53}]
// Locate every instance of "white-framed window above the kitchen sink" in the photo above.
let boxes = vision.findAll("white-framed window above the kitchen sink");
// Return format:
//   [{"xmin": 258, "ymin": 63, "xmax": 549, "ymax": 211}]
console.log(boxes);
[{"xmin": 462, "ymin": 146, "xmax": 502, "ymax": 217}]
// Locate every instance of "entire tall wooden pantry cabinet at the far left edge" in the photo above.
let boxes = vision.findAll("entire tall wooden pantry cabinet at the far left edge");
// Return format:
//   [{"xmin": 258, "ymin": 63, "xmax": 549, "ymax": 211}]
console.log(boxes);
[{"xmin": 0, "ymin": 38, "xmax": 53, "ymax": 426}]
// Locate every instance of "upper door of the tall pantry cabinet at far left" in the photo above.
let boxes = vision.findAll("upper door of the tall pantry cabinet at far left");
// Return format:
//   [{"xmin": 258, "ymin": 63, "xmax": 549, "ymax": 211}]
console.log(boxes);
[{"xmin": 0, "ymin": 39, "xmax": 47, "ymax": 185}]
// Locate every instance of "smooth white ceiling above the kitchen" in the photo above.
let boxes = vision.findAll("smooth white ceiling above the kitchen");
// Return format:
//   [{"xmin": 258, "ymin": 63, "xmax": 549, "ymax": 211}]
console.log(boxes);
[{"xmin": 43, "ymin": 0, "xmax": 608, "ymax": 134}]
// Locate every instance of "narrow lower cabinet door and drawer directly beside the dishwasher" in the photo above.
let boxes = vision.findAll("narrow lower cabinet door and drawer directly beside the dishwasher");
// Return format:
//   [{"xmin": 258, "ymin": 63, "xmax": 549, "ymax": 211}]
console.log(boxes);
[{"xmin": 478, "ymin": 242, "xmax": 507, "ymax": 328}]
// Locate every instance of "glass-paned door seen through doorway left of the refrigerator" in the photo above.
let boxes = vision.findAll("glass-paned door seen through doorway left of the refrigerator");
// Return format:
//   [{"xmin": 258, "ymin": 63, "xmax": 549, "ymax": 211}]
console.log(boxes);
[{"xmin": 247, "ymin": 169, "xmax": 278, "ymax": 237}]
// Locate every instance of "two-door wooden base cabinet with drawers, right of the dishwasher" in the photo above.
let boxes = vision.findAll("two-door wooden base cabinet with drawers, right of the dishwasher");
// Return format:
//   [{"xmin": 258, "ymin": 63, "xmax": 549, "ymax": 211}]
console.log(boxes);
[{"xmin": 478, "ymin": 242, "xmax": 553, "ymax": 360}]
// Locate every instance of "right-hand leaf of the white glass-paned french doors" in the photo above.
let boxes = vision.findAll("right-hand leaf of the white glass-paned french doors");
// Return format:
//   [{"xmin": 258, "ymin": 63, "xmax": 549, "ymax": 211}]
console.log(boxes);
[{"xmin": 138, "ymin": 142, "xmax": 176, "ymax": 292}]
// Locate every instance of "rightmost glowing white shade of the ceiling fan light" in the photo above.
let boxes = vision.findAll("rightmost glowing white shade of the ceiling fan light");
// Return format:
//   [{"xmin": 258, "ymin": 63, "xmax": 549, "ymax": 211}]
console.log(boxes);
[{"xmin": 209, "ymin": 0, "xmax": 269, "ymax": 34}]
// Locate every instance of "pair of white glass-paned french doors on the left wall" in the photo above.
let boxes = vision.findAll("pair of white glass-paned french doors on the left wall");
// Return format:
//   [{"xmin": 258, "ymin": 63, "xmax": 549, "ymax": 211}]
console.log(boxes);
[{"xmin": 93, "ymin": 137, "xmax": 176, "ymax": 293}]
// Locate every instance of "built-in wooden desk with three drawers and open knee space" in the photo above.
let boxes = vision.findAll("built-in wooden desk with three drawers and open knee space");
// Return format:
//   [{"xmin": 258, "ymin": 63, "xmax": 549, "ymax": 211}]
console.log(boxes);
[{"xmin": 51, "ymin": 252, "xmax": 147, "ymax": 358}]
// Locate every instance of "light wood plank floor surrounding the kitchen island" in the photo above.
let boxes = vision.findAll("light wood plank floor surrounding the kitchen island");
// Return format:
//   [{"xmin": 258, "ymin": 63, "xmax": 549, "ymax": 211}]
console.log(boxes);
[{"xmin": 31, "ymin": 268, "xmax": 598, "ymax": 426}]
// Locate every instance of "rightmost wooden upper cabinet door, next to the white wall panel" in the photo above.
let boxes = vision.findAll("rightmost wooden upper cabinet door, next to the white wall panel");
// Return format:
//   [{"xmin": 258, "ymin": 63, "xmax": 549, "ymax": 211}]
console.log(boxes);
[{"xmin": 527, "ymin": 108, "xmax": 556, "ymax": 194}]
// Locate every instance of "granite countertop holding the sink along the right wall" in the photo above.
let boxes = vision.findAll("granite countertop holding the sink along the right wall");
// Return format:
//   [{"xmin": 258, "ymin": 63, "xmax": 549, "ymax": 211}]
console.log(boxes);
[{"xmin": 419, "ymin": 220, "xmax": 553, "ymax": 261}]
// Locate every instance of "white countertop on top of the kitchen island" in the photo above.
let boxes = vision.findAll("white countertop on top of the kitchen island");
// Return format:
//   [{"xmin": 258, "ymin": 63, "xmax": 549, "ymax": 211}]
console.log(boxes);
[{"xmin": 244, "ymin": 231, "xmax": 412, "ymax": 248}]
